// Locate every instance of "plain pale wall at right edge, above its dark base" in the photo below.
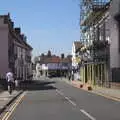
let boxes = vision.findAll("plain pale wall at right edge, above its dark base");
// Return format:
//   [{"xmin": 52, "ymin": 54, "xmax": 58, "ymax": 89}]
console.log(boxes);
[{"xmin": 110, "ymin": 0, "xmax": 120, "ymax": 68}]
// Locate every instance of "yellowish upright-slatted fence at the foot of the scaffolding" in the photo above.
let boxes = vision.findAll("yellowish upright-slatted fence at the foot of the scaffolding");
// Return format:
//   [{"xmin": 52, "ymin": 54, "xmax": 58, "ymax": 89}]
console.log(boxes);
[{"xmin": 80, "ymin": 62, "xmax": 110, "ymax": 87}]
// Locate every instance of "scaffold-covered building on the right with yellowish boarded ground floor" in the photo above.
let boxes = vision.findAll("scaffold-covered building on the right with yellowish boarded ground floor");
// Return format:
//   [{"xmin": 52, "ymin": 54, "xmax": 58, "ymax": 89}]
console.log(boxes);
[{"xmin": 80, "ymin": 0, "xmax": 111, "ymax": 87}]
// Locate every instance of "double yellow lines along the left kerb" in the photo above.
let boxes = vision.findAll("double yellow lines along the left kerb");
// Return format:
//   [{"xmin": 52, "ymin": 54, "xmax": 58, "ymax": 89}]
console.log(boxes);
[{"xmin": 2, "ymin": 92, "xmax": 26, "ymax": 120}]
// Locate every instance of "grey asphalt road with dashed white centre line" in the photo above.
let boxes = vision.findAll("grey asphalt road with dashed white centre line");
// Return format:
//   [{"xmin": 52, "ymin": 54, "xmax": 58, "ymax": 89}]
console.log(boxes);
[{"xmin": 3, "ymin": 79, "xmax": 120, "ymax": 120}]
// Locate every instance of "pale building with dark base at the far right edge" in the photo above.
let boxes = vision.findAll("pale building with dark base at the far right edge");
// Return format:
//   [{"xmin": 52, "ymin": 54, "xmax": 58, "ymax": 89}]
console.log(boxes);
[{"xmin": 109, "ymin": 0, "xmax": 120, "ymax": 82}]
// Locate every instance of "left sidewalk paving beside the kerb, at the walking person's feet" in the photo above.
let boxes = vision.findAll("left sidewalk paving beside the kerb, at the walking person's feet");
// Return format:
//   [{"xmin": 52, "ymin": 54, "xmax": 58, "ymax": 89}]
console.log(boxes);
[{"xmin": 0, "ymin": 91, "xmax": 22, "ymax": 114}]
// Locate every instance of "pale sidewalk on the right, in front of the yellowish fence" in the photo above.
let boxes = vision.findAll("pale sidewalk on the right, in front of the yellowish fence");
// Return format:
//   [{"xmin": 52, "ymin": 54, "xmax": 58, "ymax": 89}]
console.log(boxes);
[{"xmin": 62, "ymin": 78, "xmax": 120, "ymax": 101}]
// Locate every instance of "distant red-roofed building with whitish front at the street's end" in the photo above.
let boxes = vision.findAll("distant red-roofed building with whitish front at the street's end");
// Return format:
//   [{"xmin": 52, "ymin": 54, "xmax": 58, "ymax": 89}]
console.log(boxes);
[{"xmin": 36, "ymin": 54, "xmax": 72, "ymax": 76}]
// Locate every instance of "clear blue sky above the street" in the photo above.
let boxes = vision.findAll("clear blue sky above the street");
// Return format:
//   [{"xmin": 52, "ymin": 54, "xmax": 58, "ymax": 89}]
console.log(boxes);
[{"xmin": 0, "ymin": 0, "xmax": 80, "ymax": 56}]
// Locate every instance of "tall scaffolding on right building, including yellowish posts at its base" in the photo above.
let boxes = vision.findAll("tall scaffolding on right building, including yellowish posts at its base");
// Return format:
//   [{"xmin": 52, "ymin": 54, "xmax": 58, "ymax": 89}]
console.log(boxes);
[{"xmin": 80, "ymin": 0, "xmax": 111, "ymax": 85}]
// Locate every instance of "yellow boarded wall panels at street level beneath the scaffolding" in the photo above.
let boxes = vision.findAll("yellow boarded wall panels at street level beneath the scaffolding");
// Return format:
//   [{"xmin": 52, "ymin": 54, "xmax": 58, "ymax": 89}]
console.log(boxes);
[{"xmin": 80, "ymin": 63, "xmax": 108, "ymax": 86}]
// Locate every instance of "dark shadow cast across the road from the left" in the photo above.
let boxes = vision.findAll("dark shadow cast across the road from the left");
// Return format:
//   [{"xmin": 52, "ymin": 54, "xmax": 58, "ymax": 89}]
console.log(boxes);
[{"xmin": 20, "ymin": 80, "xmax": 56, "ymax": 91}]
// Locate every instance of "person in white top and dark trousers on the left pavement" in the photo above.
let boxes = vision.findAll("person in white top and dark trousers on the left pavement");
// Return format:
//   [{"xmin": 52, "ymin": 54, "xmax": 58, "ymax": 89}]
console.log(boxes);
[{"xmin": 6, "ymin": 70, "xmax": 14, "ymax": 94}]
